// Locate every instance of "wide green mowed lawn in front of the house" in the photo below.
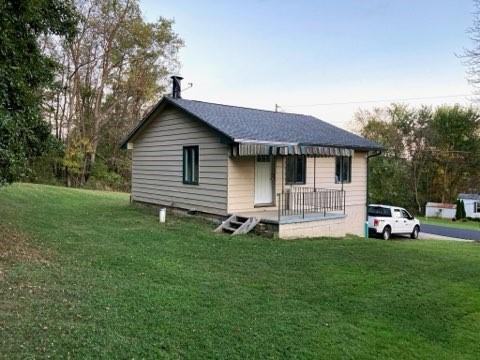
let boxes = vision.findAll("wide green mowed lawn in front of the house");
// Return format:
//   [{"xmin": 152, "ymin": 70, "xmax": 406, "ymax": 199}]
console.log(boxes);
[{"xmin": 0, "ymin": 184, "xmax": 480, "ymax": 359}]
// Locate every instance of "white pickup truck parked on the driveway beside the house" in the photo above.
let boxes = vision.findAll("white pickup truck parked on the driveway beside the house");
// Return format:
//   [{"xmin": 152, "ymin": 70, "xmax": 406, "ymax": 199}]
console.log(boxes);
[{"xmin": 368, "ymin": 204, "xmax": 420, "ymax": 240}]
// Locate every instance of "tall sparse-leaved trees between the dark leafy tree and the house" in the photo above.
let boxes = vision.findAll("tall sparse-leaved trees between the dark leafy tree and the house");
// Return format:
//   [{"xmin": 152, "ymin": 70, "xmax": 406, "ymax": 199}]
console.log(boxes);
[{"xmin": 46, "ymin": 0, "xmax": 183, "ymax": 186}]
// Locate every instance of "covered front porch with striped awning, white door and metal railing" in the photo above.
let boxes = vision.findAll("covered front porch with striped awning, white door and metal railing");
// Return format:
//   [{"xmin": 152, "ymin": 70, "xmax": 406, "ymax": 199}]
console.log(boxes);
[{"xmin": 228, "ymin": 142, "xmax": 353, "ymax": 224}]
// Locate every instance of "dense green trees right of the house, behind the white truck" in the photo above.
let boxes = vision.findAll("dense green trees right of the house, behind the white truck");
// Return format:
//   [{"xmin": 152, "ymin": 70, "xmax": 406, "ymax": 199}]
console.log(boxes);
[{"xmin": 356, "ymin": 104, "xmax": 480, "ymax": 213}]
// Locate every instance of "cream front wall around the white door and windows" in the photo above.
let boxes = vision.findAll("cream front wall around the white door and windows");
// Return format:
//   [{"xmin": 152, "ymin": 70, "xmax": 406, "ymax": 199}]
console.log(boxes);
[{"xmin": 228, "ymin": 152, "xmax": 367, "ymax": 236}]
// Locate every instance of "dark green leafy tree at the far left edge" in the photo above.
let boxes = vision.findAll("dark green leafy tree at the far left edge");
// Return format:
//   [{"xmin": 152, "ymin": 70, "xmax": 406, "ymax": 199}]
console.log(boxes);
[{"xmin": 0, "ymin": 0, "xmax": 76, "ymax": 185}]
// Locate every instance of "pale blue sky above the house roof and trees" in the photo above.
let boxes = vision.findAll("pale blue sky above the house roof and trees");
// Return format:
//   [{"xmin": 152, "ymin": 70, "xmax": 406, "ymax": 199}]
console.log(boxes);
[{"xmin": 140, "ymin": 0, "xmax": 474, "ymax": 129}]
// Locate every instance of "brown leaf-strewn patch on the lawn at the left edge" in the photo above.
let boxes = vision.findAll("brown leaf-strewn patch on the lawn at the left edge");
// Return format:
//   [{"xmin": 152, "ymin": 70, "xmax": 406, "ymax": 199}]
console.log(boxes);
[{"xmin": 0, "ymin": 224, "xmax": 48, "ymax": 279}]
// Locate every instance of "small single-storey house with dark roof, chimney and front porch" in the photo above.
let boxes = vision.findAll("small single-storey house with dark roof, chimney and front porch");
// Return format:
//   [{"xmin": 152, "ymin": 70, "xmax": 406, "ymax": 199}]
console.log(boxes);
[{"xmin": 122, "ymin": 77, "xmax": 381, "ymax": 238}]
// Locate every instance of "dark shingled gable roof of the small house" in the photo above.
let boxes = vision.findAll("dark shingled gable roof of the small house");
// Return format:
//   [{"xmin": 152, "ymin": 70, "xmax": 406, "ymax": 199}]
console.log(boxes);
[{"xmin": 123, "ymin": 97, "xmax": 382, "ymax": 150}]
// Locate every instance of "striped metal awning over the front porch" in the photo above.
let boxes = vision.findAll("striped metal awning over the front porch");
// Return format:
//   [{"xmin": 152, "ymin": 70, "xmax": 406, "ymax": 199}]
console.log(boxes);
[{"xmin": 232, "ymin": 140, "xmax": 354, "ymax": 157}]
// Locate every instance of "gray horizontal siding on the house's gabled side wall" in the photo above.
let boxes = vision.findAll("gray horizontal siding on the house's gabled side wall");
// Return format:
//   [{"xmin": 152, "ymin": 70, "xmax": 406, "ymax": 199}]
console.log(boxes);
[{"xmin": 132, "ymin": 108, "xmax": 228, "ymax": 215}]
